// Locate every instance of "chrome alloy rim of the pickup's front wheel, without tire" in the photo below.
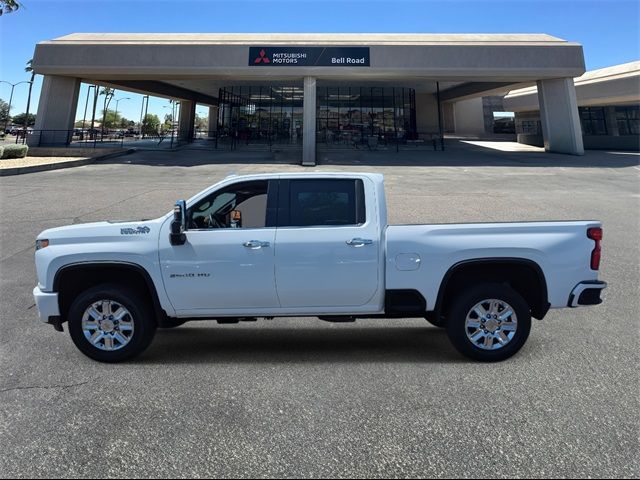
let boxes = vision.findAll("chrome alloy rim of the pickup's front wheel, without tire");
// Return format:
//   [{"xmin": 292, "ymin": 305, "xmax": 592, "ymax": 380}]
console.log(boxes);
[{"xmin": 82, "ymin": 300, "xmax": 134, "ymax": 352}]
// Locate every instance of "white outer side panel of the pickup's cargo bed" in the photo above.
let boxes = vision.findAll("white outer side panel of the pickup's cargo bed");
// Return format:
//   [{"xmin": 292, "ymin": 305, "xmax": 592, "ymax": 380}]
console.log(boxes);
[{"xmin": 386, "ymin": 220, "xmax": 601, "ymax": 311}]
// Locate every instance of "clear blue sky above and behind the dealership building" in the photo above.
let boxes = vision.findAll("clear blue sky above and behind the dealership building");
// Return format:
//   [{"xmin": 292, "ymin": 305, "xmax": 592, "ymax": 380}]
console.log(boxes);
[{"xmin": 0, "ymin": 0, "xmax": 640, "ymax": 124}]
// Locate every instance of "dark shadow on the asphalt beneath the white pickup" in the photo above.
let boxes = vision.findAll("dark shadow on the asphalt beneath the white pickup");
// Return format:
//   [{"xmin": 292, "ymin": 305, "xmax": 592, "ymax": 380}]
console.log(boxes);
[{"xmin": 137, "ymin": 324, "xmax": 468, "ymax": 364}]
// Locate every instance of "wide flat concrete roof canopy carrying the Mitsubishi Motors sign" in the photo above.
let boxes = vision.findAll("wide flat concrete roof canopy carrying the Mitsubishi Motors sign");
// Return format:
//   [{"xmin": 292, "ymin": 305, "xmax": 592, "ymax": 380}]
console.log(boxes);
[{"xmin": 33, "ymin": 33, "xmax": 584, "ymax": 103}]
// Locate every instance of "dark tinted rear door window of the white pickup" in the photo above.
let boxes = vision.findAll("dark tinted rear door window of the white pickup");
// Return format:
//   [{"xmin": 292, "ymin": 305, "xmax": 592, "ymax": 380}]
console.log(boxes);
[{"xmin": 281, "ymin": 180, "xmax": 365, "ymax": 227}]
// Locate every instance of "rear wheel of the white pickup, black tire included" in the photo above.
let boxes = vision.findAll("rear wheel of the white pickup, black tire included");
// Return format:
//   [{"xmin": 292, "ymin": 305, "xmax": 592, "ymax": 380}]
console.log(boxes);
[{"xmin": 445, "ymin": 283, "xmax": 531, "ymax": 362}]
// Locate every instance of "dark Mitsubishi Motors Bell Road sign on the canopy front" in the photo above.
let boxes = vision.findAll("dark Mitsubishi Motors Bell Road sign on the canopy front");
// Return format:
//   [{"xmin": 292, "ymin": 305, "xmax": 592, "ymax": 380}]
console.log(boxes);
[{"xmin": 249, "ymin": 47, "xmax": 370, "ymax": 67}]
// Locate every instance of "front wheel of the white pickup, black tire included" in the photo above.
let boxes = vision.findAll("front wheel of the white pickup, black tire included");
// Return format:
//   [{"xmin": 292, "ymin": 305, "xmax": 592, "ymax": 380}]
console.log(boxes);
[{"xmin": 68, "ymin": 284, "xmax": 156, "ymax": 363}]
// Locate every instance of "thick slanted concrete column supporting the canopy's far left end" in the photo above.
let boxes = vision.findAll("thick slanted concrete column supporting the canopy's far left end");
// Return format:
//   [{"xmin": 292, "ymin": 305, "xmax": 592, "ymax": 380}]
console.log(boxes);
[{"xmin": 27, "ymin": 75, "xmax": 80, "ymax": 147}]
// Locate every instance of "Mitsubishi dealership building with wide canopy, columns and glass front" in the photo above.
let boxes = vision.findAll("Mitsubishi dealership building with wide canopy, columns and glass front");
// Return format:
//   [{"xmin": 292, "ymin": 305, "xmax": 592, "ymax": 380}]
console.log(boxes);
[{"xmin": 29, "ymin": 34, "xmax": 585, "ymax": 165}]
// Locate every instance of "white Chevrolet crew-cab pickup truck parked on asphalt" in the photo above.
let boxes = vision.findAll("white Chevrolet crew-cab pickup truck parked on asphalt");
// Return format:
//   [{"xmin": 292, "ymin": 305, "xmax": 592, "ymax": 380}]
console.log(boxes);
[{"xmin": 33, "ymin": 173, "xmax": 606, "ymax": 362}]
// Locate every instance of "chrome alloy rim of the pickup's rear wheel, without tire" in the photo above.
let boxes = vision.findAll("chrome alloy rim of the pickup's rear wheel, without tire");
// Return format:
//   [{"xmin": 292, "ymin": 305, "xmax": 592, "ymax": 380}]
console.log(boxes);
[{"xmin": 465, "ymin": 298, "xmax": 518, "ymax": 350}]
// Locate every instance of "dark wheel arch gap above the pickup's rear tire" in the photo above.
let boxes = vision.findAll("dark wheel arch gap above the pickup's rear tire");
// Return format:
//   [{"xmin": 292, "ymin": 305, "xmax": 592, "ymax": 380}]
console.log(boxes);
[{"xmin": 434, "ymin": 257, "xmax": 550, "ymax": 320}]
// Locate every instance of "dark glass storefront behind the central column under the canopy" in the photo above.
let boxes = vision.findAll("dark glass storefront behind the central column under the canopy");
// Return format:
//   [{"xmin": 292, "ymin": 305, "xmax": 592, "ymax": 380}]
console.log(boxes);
[{"xmin": 218, "ymin": 86, "xmax": 416, "ymax": 145}]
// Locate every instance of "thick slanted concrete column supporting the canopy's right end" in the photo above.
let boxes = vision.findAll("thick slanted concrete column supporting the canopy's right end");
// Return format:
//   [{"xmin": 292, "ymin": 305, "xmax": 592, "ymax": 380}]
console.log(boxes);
[{"xmin": 537, "ymin": 78, "xmax": 584, "ymax": 155}]
